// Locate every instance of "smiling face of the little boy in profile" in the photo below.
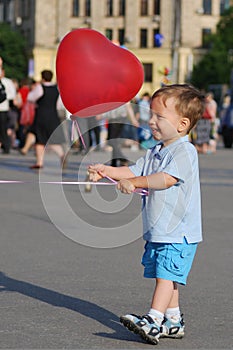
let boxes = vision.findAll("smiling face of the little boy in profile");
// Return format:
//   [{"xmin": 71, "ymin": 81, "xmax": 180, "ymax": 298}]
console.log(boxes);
[{"xmin": 149, "ymin": 96, "xmax": 184, "ymax": 146}]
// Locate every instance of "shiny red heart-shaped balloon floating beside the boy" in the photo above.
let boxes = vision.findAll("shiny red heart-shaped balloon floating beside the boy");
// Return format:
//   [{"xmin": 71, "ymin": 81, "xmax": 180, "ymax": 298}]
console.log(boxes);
[{"xmin": 56, "ymin": 28, "xmax": 144, "ymax": 117}]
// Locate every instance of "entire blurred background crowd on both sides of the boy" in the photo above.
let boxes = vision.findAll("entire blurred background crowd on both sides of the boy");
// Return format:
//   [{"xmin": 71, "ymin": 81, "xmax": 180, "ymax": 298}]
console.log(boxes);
[{"xmin": 0, "ymin": 58, "xmax": 233, "ymax": 169}]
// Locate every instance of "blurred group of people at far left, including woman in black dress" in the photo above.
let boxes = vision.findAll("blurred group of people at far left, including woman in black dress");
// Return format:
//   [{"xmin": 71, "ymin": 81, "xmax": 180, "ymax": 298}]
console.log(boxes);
[{"xmin": 0, "ymin": 59, "xmax": 65, "ymax": 169}]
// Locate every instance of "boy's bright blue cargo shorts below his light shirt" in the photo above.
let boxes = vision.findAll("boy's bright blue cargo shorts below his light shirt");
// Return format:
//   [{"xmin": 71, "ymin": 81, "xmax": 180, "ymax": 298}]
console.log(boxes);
[{"xmin": 142, "ymin": 238, "xmax": 197, "ymax": 284}]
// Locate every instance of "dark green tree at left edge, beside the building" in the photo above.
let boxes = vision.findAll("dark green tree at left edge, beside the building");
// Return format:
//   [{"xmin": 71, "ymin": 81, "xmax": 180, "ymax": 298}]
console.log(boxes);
[{"xmin": 0, "ymin": 23, "xmax": 28, "ymax": 81}]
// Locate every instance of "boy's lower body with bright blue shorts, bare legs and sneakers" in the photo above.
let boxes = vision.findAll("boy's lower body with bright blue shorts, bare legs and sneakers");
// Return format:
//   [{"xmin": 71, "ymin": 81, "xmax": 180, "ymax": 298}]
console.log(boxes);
[{"xmin": 121, "ymin": 240, "xmax": 197, "ymax": 344}]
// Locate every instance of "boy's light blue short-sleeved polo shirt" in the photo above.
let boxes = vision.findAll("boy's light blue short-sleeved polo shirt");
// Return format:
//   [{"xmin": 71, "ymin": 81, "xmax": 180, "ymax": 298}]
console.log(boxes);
[{"xmin": 130, "ymin": 136, "xmax": 202, "ymax": 243}]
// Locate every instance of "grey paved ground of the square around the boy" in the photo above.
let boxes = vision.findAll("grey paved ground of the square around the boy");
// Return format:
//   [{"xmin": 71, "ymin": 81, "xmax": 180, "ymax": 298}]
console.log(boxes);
[{"xmin": 0, "ymin": 144, "xmax": 233, "ymax": 349}]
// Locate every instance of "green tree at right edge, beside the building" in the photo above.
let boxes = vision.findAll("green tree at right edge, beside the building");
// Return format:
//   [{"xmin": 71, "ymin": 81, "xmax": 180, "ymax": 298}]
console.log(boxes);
[{"xmin": 191, "ymin": 7, "xmax": 233, "ymax": 90}]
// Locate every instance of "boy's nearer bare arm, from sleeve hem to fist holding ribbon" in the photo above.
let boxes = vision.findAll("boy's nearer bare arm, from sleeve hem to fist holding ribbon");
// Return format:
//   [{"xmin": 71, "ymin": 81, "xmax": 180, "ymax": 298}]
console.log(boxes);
[{"xmin": 117, "ymin": 172, "xmax": 178, "ymax": 193}]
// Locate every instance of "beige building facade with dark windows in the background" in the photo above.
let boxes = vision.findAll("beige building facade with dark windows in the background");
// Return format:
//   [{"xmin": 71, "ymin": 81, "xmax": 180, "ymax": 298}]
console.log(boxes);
[{"xmin": 0, "ymin": 0, "xmax": 232, "ymax": 92}]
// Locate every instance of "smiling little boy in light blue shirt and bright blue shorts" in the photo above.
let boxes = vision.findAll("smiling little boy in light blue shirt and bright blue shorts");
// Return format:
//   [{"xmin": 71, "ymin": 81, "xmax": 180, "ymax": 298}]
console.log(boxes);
[{"xmin": 89, "ymin": 84, "xmax": 204, "ymax": 344}]
